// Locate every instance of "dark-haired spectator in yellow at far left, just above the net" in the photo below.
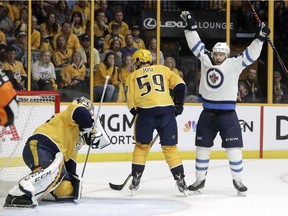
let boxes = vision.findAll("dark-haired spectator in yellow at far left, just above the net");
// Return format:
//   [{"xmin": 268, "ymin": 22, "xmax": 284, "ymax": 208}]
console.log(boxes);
[{"xmin": 3, "ymin": 46, "xmax": 27, "ymax": 90}]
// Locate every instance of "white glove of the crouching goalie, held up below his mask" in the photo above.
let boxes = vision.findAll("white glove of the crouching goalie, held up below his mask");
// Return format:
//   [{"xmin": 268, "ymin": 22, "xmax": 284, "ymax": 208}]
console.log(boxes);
[{"xmin": 81, "ymin": 119, "xmax": 111, "ymax": 149}]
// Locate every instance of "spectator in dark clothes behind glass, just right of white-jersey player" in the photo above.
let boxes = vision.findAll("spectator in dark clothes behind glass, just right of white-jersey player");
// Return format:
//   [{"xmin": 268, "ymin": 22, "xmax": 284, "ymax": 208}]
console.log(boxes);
[{"xmin": 243, "ymin": 67, "xmax": 263, "ymax": 103}]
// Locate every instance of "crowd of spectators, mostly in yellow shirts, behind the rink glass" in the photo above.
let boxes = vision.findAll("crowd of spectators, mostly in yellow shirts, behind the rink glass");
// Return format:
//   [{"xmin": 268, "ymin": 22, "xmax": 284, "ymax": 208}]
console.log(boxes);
[{"xmin": 0, "ymin": 0, "xmax": 288, "ymax": 103}]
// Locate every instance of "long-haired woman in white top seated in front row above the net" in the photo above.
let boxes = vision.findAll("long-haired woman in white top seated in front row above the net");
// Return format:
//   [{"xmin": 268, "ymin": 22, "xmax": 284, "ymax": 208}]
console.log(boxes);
[{"xmin": 32, "ymin": 50, "xmax": 58, "ymax": 91}]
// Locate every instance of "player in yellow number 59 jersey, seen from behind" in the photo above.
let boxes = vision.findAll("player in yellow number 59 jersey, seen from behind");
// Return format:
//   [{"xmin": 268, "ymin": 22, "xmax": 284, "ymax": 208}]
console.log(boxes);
[{"xmin": 126, "ymin": 49, "xmax": 188, "ymax": 195}]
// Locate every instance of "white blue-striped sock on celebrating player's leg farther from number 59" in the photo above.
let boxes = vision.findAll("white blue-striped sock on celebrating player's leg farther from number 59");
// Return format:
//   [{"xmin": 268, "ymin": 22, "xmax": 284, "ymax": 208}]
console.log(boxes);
[{"xmin": 226, "ymin": 148, "xmax": 243, "ymax": 181}]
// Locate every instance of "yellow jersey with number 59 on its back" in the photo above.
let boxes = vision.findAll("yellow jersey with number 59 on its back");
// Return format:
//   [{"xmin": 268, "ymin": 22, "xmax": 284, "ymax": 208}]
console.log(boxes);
[{"xmin": 126, "ymin": 65, "xmax": 185, "ymax": 110}]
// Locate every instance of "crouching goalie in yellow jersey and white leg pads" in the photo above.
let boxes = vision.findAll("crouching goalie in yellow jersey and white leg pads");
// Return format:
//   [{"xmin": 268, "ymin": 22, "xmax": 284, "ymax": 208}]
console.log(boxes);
[{"xmin": 4, "ymin": 97, "xmax": 110, "ymax": 208}]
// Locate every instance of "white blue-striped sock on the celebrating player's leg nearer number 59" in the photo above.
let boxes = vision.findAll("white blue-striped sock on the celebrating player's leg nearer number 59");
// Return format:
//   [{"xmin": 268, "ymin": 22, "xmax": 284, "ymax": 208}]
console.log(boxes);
[{"xmin": 195, "ymin": 146, "xmax": 211, "ymax": 181}]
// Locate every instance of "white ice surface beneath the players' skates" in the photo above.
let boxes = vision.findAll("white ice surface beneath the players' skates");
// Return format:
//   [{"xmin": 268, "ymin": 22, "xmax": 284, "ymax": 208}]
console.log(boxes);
[{"xmin": 0, "ymin": 159, "xmax": 288, "ymax": 216}]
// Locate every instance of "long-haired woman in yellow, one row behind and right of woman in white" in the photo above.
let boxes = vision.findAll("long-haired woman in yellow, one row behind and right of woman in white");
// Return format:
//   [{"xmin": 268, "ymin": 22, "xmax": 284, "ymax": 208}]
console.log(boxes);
[{"xmin": 52, "ymin": 35, "xmax": 72, "ymax": 67}]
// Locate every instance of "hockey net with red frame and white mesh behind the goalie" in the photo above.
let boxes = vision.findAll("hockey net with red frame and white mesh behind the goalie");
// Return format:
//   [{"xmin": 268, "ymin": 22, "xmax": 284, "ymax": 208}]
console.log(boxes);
[{"xmin": 0, "ymin": 91, "xmax": 60, "ymax": 196}]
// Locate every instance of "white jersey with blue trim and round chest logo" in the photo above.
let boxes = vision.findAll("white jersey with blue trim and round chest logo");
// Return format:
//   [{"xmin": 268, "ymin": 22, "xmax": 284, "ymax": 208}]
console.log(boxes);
[{"xmin": 185, "ymin": 30, "xmax": 263, "ymax": 110}]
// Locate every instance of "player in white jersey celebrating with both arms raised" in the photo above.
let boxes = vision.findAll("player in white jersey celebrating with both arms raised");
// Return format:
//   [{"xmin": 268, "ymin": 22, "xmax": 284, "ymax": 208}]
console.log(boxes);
[{"xmin": 180, "ymin": 11, "xmax": 270, "ymax": 194}]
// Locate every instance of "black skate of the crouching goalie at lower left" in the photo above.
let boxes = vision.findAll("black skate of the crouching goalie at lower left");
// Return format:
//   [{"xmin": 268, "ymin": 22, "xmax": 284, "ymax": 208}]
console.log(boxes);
[{"xmin": 3, "ymin": 194, "xmax": 37, "ymax": 208}]
